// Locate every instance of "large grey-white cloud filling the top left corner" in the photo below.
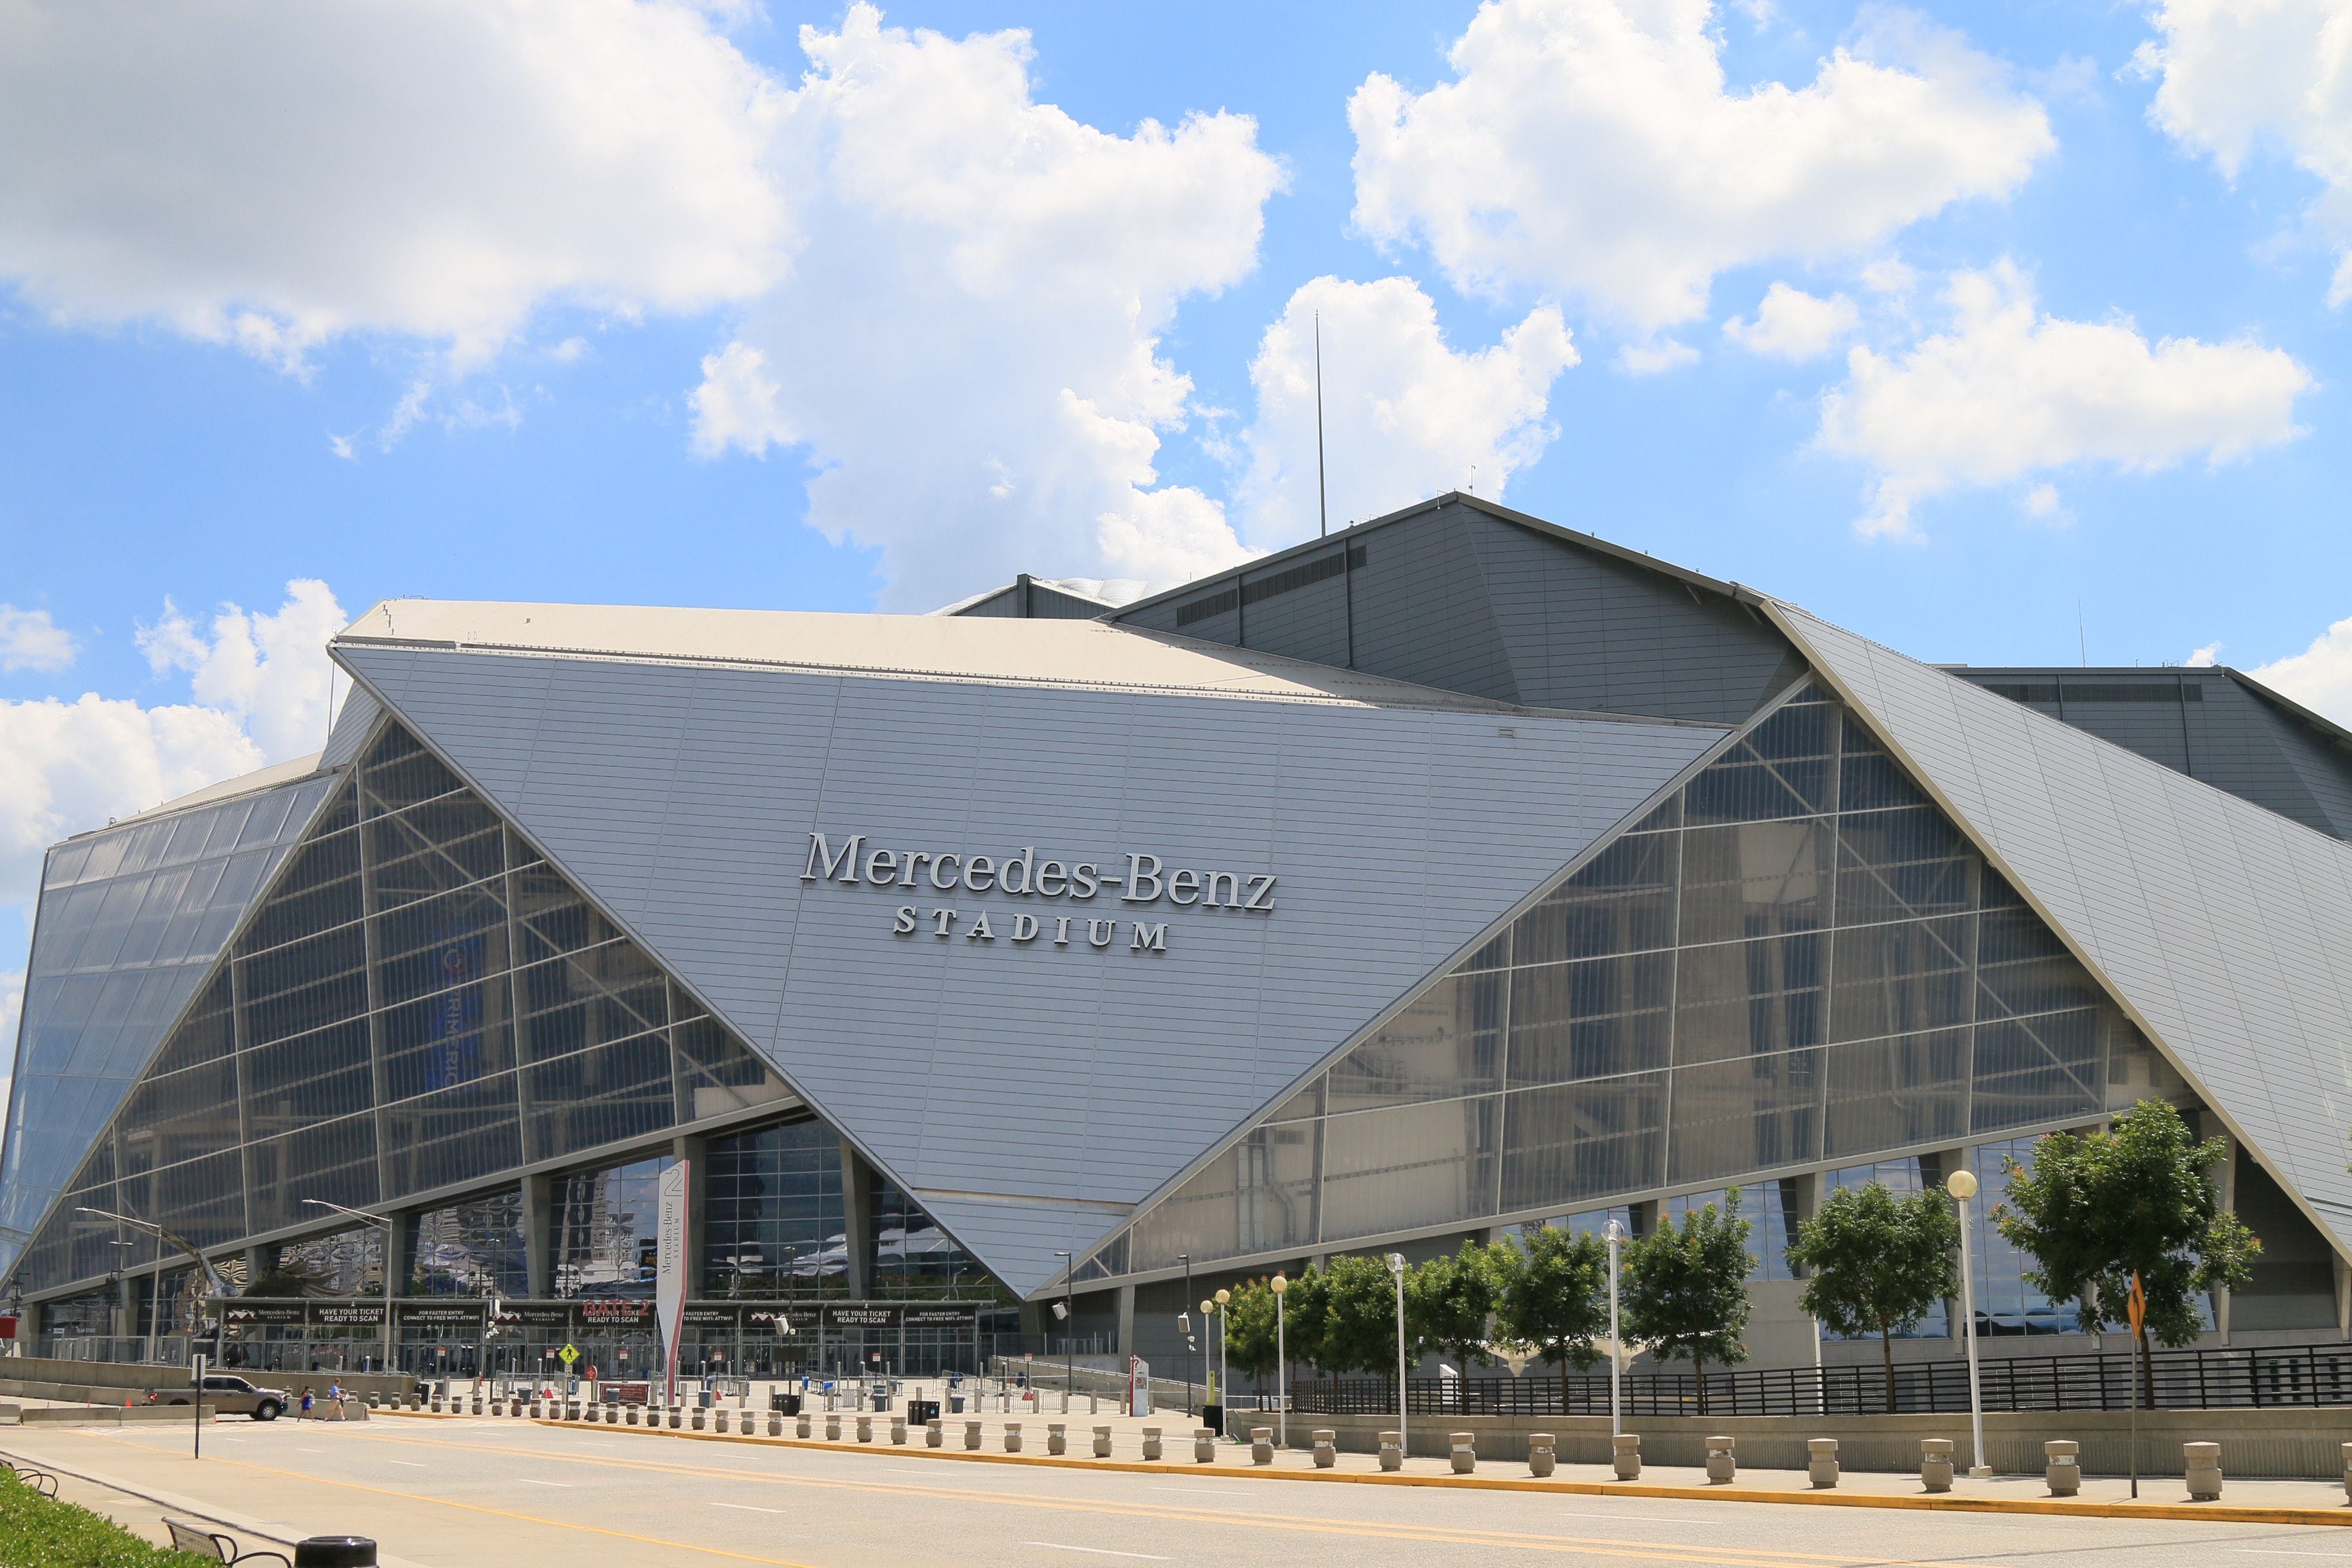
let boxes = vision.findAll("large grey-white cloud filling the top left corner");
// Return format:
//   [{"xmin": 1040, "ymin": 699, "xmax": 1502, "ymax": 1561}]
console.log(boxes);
[{"xmin": 0, "ymin": 0, "xmax": 790, "ymax": 369}]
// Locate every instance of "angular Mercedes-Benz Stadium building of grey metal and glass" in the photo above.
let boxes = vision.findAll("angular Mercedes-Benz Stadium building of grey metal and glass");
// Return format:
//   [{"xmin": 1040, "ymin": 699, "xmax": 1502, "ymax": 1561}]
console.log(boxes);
[{"xmin": 0, "ymin": 496, "xmax": 2352, "ymax": 1371}]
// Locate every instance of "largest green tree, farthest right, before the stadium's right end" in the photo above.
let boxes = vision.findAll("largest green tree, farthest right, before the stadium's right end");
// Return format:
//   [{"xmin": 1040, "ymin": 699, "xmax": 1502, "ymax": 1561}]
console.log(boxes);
[{"xmin": 1992, "ymin": 1100, "xmax": 2262, "ymax": 1387}]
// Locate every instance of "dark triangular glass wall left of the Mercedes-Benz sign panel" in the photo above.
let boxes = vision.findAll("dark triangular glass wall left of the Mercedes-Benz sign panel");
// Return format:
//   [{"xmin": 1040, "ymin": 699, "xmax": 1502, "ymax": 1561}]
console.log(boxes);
[{"xmin": 19, "ymin": 724, "xmax": 788, "ymax": 1291}]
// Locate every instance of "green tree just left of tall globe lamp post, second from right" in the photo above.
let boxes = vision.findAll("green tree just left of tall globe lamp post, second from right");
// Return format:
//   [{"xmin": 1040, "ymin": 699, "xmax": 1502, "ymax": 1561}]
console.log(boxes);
[{"xmin": 1787, "ymin": 1182, "xmax": 1959, "ymax": 1413}]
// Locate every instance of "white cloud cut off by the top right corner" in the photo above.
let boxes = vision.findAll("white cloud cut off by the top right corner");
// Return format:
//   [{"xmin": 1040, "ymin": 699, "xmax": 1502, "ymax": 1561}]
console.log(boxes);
[{"xmin": 2133, "ymin": 0, "xmax": 2352, "ymax": 306}]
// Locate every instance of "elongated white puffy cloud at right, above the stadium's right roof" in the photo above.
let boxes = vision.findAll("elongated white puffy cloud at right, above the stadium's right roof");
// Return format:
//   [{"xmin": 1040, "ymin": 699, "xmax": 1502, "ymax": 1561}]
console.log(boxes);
[{"xmin": 1818, "ymin": 261, "xmax": 2312, "ymax": 536}]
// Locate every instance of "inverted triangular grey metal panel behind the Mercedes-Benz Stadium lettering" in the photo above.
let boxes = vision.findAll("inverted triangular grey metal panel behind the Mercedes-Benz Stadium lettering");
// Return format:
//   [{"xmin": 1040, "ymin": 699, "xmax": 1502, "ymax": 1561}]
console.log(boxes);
[{"xmin": 341, "ymin": 647, "xmax": 1721, "ymax": 1291}]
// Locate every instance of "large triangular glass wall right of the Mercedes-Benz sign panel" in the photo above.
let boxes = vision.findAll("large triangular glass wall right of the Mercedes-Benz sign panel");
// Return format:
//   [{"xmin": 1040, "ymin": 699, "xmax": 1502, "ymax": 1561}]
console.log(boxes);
[{"xmin": 1119, "ymin": 684, "xmax": 2185, "ymax": 1277}]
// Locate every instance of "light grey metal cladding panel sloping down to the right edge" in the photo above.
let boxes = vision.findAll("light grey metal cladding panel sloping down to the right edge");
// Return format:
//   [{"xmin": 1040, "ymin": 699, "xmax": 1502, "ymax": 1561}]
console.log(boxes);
[{"xmin": 1778, "ymin": 607, "xmax": 2352, "ymax": 1244}]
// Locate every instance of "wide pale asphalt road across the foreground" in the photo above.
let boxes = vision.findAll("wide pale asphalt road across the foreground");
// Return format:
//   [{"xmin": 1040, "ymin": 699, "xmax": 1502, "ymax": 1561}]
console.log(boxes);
[{"xmin": 14, "ymin": 1418, "xmax": 2352, "ymax": 1568}]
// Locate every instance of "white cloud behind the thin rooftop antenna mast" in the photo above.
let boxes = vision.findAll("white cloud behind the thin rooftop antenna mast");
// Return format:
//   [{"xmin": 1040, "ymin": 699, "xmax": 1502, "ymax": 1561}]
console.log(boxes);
[{"xmin": 1239, "ymin": 277, "xmax": 1576, "ymax": 545}]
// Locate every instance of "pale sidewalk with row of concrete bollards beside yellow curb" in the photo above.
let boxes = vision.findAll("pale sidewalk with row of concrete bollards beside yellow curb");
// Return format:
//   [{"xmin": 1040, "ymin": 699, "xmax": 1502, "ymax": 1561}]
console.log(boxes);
[{"xmin": 384, "ymin": 1411, "xmax": 2352, "ymax": 1525}]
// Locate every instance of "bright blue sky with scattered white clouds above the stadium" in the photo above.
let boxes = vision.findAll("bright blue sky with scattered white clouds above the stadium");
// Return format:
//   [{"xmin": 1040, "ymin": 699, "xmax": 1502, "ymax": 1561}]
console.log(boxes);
[{"xmin": 0, "ymin": 0, "xmax": 2352, "ymax": 1024}]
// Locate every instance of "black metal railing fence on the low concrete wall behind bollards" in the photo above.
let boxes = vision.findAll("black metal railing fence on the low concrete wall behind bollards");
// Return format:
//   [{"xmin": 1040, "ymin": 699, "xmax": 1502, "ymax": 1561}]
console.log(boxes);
[{"xmin": 1291, "ymin": 1345, "xmax": 2352, "ymax": 1415}]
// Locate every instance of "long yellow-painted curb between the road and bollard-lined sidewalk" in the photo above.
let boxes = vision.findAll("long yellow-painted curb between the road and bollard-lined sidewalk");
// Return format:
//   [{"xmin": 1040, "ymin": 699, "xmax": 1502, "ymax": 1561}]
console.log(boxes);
[{"xmin": 384, "ymin": 1411, "xmax": 2352, "ymax": 1525}]
